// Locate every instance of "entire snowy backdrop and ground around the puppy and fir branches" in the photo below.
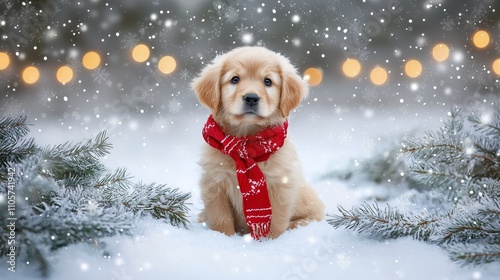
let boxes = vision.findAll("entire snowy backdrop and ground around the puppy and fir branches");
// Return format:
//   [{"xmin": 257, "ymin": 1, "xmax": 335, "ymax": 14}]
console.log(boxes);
[{"xmin": 0, "ymin": 0, "xmax": 500, "ymax": 279}]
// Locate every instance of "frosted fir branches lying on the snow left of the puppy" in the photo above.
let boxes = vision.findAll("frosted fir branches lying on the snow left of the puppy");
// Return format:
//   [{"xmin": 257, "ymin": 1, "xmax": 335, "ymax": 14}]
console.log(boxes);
[{"xmin": 0, "ymin": 117, "xmax": 190, "ymax": 276}]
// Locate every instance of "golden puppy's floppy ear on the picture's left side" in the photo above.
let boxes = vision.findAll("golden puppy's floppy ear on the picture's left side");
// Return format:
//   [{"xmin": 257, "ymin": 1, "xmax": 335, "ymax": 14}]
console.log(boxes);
[{"xmin": 191, "ymin": 58, "xmax": 222, "ymax": 115}]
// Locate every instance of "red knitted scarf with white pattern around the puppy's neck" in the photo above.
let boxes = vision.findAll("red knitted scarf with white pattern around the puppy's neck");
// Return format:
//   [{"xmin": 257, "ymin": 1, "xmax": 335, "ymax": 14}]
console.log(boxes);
[{"xmin": 203, "ymin": 116, "xmax": 288, "ymax": 239}]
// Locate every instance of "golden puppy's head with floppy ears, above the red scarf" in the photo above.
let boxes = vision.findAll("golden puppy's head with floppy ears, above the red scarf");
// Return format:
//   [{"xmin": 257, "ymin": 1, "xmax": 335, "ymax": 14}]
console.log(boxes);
[{"xmin": 192, "ymin": 47, "xmax": 308, "ymax": 133}]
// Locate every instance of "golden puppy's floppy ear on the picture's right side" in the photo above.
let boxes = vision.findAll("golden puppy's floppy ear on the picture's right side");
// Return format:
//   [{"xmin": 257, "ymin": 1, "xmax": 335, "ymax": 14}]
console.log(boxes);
[{"xmin": 279, "ymin": 57, "xmax": 309, "ymax": 118}]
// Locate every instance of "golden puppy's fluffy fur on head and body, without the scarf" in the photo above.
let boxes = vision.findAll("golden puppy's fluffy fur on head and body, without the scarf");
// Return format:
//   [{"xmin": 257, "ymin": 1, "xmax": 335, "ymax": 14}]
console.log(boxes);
[{"xmin": 192, "ymin": 47, "xmax": 324, "ymax": 237}]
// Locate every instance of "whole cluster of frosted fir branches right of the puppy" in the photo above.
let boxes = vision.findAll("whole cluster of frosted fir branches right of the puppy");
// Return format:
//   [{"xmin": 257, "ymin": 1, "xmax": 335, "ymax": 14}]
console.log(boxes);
[{"xmin": 328, "ymin": 100, "xmax": 500, "ymax": 265}]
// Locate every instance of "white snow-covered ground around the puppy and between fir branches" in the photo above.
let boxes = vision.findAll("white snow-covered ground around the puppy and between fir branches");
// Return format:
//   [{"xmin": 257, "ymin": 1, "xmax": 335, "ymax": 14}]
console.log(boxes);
[{"xmin": 6, "ymin": 106, "xmax": 500, "ymax": 280}]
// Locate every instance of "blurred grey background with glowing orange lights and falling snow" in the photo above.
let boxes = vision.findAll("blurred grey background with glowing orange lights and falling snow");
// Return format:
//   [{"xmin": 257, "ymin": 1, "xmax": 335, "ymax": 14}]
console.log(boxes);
[{"xmin": 0, "ymin": 0, "xmax": 500, "ymax": 138}]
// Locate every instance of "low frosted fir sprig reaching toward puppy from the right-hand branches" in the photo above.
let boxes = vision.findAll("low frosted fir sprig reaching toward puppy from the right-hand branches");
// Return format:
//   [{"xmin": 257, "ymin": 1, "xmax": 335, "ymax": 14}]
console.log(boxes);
[{"xmin": 327, "ymin": 202, "xmax": 438, "ymax": 240}]
